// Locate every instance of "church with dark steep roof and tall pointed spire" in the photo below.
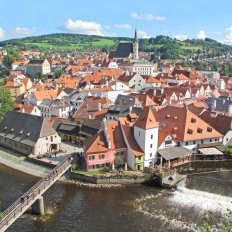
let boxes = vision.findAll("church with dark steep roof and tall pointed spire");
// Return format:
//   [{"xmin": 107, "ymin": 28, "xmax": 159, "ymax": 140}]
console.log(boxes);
[{"xmin": 109, "ymin": 29, "xmax": 139, "ymax": 63}]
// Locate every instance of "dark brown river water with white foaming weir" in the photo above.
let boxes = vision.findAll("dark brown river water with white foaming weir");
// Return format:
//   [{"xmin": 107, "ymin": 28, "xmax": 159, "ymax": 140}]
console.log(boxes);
[{"xmin": 0, "ymin": 165, "xmax": 232, "ymax": 232}]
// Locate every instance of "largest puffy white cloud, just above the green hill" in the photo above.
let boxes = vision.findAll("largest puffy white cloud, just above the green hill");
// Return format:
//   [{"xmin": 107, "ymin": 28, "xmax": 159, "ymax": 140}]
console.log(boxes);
[{"xmin": 64, "ymin": 19, "xmax": 103, "ymax": 35}]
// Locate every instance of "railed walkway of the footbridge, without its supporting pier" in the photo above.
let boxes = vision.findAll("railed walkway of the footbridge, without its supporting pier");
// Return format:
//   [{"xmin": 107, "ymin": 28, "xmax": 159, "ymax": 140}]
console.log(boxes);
[{"xmin": 0, "ymin": 158, "xmax": 72, "ymax": 229}]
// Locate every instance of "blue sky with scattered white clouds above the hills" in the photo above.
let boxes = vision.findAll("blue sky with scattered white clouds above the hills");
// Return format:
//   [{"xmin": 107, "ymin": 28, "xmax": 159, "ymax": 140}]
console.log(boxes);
[{"xmin": 0, "ymin": 0, "xmax": 232, "ymax": 45}]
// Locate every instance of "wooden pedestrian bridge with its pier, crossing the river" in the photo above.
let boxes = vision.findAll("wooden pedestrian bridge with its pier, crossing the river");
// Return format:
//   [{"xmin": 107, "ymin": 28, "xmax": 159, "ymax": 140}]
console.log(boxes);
[{"xmin": 0, "ymin": 158, "xmax": 72, "ymax": 232}]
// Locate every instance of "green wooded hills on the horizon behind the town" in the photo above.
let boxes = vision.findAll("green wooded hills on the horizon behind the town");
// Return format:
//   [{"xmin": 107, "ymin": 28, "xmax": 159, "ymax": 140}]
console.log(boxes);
[{"xmin": 0, "ymin": 33, "xmax": 232, "ymax": 59}]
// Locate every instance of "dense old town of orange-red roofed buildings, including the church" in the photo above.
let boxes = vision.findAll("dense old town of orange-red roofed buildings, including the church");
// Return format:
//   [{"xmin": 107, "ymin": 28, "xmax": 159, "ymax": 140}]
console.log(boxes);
[{"xmin": 0, "ymin": 30, "xmax": 232, "ymax": 183}]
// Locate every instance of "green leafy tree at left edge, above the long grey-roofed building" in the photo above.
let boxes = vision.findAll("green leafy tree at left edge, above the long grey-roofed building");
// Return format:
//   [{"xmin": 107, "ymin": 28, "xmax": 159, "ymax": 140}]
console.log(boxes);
[{"xmin": 0, "ymin": 89, "xmax": 14, "ymax": 121}]
